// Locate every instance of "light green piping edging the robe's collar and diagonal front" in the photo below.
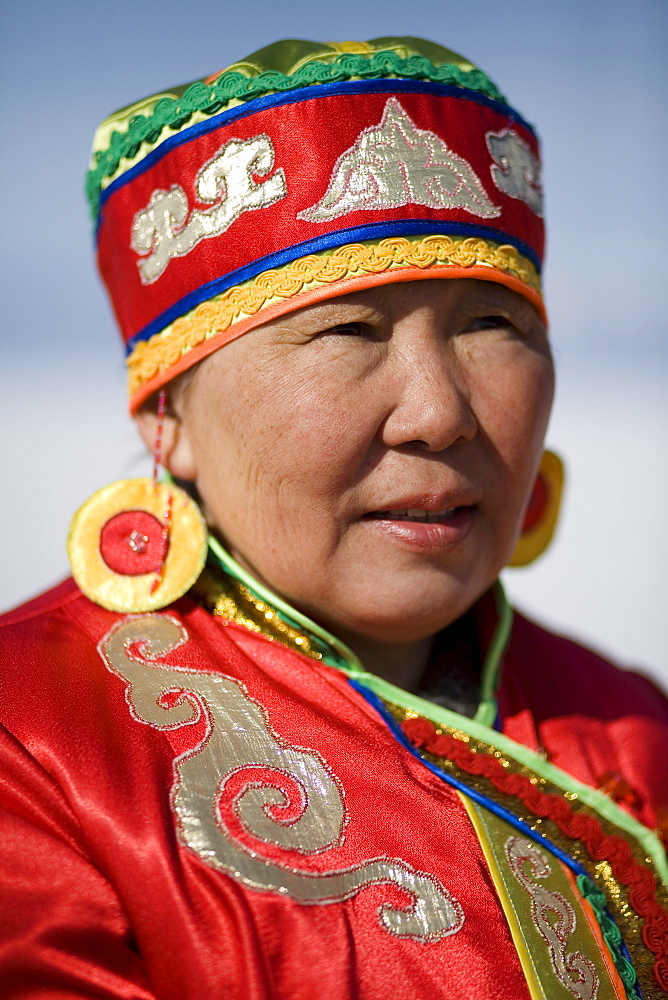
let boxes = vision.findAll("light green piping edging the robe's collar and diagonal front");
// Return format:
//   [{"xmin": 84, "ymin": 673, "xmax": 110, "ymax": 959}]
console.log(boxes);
[{"xmin": 209, "ymin": 536, "xmax": 668, "ymax": 884}]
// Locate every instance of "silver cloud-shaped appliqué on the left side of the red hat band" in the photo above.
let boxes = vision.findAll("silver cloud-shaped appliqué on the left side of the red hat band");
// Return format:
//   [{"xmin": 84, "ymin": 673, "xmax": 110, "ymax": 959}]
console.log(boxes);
[{"xmin": 131, "ymin": 135, "xmax": 288, "ymax": 285}]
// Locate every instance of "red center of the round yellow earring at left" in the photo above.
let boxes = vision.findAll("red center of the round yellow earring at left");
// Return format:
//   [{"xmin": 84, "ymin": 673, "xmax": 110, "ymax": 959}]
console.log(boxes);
[{"xmin": 100, "ymin": 510, "xmax": 165, "ymax": 576}]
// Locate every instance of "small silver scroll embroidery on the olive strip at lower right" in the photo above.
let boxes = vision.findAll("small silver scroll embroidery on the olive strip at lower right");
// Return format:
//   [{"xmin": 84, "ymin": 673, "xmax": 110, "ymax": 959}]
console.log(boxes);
[{"xmin": 505, "ymin": 837, "xmax": 599, "ymax": 1000}]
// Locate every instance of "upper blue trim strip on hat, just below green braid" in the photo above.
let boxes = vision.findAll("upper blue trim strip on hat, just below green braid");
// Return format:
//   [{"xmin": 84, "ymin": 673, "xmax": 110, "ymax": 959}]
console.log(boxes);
[{"xmin": 97, "ymin": 79, "xmax": 535, "ymax": 228}]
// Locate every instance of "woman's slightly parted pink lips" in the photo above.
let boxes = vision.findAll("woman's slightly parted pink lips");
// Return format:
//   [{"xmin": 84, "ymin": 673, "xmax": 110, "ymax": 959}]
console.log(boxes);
[{"xmin": 362, "ymin": 504, "xmax": 478, "ymax": 552}]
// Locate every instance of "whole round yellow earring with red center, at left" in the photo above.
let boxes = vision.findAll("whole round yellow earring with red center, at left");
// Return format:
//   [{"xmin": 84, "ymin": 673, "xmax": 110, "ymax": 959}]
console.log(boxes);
[{"xmin": 67, "ymin": 479, "xmax": 207, "ymax": 614}]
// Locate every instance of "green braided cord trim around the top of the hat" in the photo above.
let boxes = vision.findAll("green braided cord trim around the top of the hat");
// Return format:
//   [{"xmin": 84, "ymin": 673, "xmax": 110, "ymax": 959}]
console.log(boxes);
[{"xmin": 86, "ymin": 49, "xmax": 504, "ymax": 218}]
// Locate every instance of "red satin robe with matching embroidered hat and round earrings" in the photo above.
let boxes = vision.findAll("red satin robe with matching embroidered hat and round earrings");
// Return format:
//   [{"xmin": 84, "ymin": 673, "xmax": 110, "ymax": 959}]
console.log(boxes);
[{"xmin": 0, "ymin": 39, "xmax": 668, "ymax": 1000}]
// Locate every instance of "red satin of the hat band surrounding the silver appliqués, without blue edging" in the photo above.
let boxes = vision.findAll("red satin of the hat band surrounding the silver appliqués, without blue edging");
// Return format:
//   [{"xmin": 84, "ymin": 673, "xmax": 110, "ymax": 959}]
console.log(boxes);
[{"xmin": 98, "ymin": 90, "xmax": 544, "ymax": 342}]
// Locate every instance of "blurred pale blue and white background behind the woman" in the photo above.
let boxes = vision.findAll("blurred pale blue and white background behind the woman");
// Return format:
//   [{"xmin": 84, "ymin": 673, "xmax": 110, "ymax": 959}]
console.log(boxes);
[{"xmin": 0, "ymin": 0, "xmax": 668, "ymax": 684}]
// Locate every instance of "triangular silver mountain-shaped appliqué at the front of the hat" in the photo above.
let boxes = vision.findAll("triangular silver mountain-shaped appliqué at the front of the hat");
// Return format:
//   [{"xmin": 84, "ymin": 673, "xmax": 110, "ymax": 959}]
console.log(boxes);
[{"xmin": 297, "ymin": 97, "xmax": 501, "ymax": 222}]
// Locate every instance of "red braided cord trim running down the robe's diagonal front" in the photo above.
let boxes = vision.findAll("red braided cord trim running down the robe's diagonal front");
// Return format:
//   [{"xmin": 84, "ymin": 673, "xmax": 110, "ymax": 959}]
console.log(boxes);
[{"xmin": 401, "ymin": 718, "xmax": 668, "ymax": 996}]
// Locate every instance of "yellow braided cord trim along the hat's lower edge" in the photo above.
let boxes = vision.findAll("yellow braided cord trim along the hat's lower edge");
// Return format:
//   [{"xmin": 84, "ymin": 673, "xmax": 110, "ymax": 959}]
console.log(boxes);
[{"xmin": 127, "ymin": 236, "xmax": 540, "ymax": 394}]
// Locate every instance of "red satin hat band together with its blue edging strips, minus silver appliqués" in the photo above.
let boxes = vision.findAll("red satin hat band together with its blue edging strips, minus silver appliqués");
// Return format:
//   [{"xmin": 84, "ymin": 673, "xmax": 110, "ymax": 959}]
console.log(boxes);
[{"xmin": 97, "ymin": 87, "xmax": 544, "ymax": 352}]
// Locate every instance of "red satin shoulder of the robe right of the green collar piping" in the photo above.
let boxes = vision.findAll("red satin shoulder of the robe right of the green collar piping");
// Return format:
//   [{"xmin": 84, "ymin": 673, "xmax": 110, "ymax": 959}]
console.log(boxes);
[{"xmin": 499, "ymin": 614, "xmax": 668, "ymax": 828}]
